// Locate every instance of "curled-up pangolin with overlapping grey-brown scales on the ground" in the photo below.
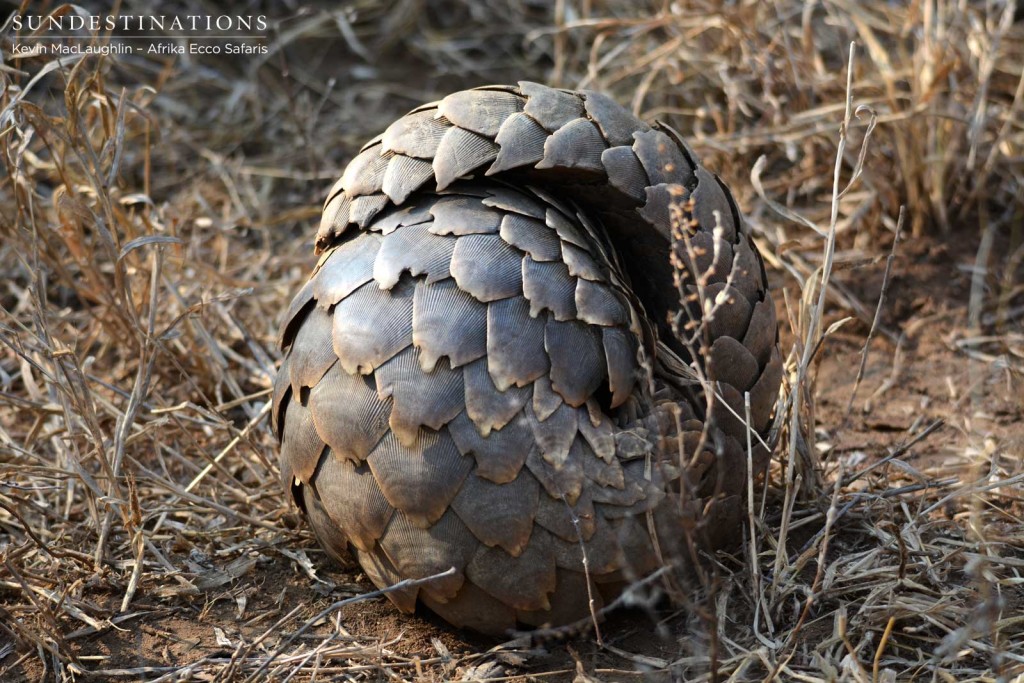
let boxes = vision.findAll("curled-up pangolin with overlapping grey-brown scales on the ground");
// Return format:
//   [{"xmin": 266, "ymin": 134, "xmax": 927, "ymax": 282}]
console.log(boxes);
[{"xmin": 272, "ymin": 82, "xmax": 782, "ymax": 633}]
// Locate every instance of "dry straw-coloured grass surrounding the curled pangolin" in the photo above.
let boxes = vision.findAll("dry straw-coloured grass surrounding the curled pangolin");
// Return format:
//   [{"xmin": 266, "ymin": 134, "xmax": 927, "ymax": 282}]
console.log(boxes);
[{"xmin": 0, "ymin": 0, "xmax": 1024, "ymax": 681}]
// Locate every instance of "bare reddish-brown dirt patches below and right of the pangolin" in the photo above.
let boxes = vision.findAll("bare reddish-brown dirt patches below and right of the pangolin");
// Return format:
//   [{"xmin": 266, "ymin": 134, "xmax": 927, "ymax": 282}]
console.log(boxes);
[{"xmin": 6, "ymin": 229, "xmax": 1024, "ymax": 681}]
